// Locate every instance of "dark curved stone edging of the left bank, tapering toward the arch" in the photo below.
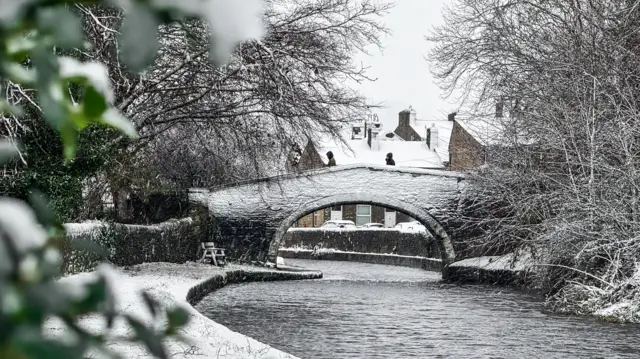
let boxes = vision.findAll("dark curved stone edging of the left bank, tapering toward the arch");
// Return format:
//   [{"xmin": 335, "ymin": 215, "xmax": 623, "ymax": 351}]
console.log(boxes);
[{"xmin": 187, "ymin": 270, "xmax": 322, "ymax": 305}]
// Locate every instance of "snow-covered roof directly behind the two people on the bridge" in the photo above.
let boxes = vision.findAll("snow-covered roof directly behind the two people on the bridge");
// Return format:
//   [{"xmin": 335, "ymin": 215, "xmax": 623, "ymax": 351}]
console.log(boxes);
[{"xmin": 316, "ymin": 131, "xmax": 444, "ymax": 168}]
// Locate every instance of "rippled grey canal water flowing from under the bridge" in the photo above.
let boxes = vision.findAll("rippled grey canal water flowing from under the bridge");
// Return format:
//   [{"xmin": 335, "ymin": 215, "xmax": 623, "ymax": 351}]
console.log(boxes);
[{"xmin": 197, "ymin": 260, "xmax": 640, "ymax": 359}]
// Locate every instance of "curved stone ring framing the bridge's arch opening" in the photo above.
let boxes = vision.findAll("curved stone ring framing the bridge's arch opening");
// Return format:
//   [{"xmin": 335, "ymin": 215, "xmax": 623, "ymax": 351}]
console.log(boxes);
[{"xmin": 269, "ymin": 192, "xmax": 455, "ymax": 266}]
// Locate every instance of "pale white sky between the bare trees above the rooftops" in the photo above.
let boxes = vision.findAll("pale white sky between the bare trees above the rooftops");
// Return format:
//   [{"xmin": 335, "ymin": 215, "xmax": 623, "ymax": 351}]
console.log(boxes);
[{"xmin": 356, "ymin": 0, "xmax": 457, "ymax": 130}]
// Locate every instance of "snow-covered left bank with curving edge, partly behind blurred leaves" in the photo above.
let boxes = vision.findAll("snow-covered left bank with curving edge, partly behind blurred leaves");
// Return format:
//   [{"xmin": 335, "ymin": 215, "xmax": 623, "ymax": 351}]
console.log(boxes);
[{"xmin": 45, "ymin": 263, "xmax": 322, "ymax": 359}]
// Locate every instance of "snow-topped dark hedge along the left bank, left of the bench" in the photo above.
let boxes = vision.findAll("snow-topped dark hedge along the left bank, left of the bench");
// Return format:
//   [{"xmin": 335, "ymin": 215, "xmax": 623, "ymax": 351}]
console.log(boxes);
[{"xmin": 62, "ymin": 218, "xmax": 209, "ymax": 274}]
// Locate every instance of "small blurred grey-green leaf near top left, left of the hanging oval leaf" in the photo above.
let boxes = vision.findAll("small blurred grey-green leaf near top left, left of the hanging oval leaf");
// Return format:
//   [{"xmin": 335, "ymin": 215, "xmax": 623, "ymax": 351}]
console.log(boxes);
[{"xmin": 37, "ymin": 5, "xmax": 84, "ymax": 49}]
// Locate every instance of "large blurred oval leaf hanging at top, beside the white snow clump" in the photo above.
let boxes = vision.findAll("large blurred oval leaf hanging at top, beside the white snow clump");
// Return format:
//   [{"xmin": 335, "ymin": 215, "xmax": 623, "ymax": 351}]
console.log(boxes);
[{"xmin": 119, "ymin": 2, "xmax": 160, "ymax": 72}]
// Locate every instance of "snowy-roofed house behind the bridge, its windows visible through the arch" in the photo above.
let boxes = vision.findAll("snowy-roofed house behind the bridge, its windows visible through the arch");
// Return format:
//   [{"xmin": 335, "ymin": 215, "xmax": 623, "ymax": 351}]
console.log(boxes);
[{"xmin": 296, "ymin": 116, "xmax": 446, "ymax": 227}]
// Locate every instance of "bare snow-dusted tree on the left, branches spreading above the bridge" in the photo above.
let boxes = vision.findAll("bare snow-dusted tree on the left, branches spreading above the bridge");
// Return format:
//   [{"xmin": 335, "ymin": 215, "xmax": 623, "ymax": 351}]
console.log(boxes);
[{"xmin": 70, "ymin": 0, "xmax": 391, "ymax": 219}]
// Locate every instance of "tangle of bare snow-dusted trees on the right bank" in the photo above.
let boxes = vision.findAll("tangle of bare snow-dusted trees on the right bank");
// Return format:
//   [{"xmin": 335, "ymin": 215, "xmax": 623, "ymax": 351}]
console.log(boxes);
[{"xmin": 428, "ymin": 0, "xmax": 640, "ymax": 312}]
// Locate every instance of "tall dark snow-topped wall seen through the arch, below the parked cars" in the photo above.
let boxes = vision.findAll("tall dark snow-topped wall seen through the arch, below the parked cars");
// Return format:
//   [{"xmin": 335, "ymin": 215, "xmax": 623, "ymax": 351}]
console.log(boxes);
[{"xmin": 282, "ymin": 228, "xmax": 440, "ymax": 258}]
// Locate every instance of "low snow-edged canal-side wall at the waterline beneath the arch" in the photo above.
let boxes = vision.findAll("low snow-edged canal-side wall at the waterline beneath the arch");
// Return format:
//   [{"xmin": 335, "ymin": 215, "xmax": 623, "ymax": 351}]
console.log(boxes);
[{"xmin": 278, "ymin": 250, "xmax": 442, "ymax": 272}]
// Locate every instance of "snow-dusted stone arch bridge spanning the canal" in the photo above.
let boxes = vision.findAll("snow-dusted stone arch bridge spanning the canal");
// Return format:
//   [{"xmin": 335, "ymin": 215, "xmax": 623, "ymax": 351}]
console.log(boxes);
[{"xmin": 189, "ymin": 165, "xmax": 464, "ymax": 264}]
